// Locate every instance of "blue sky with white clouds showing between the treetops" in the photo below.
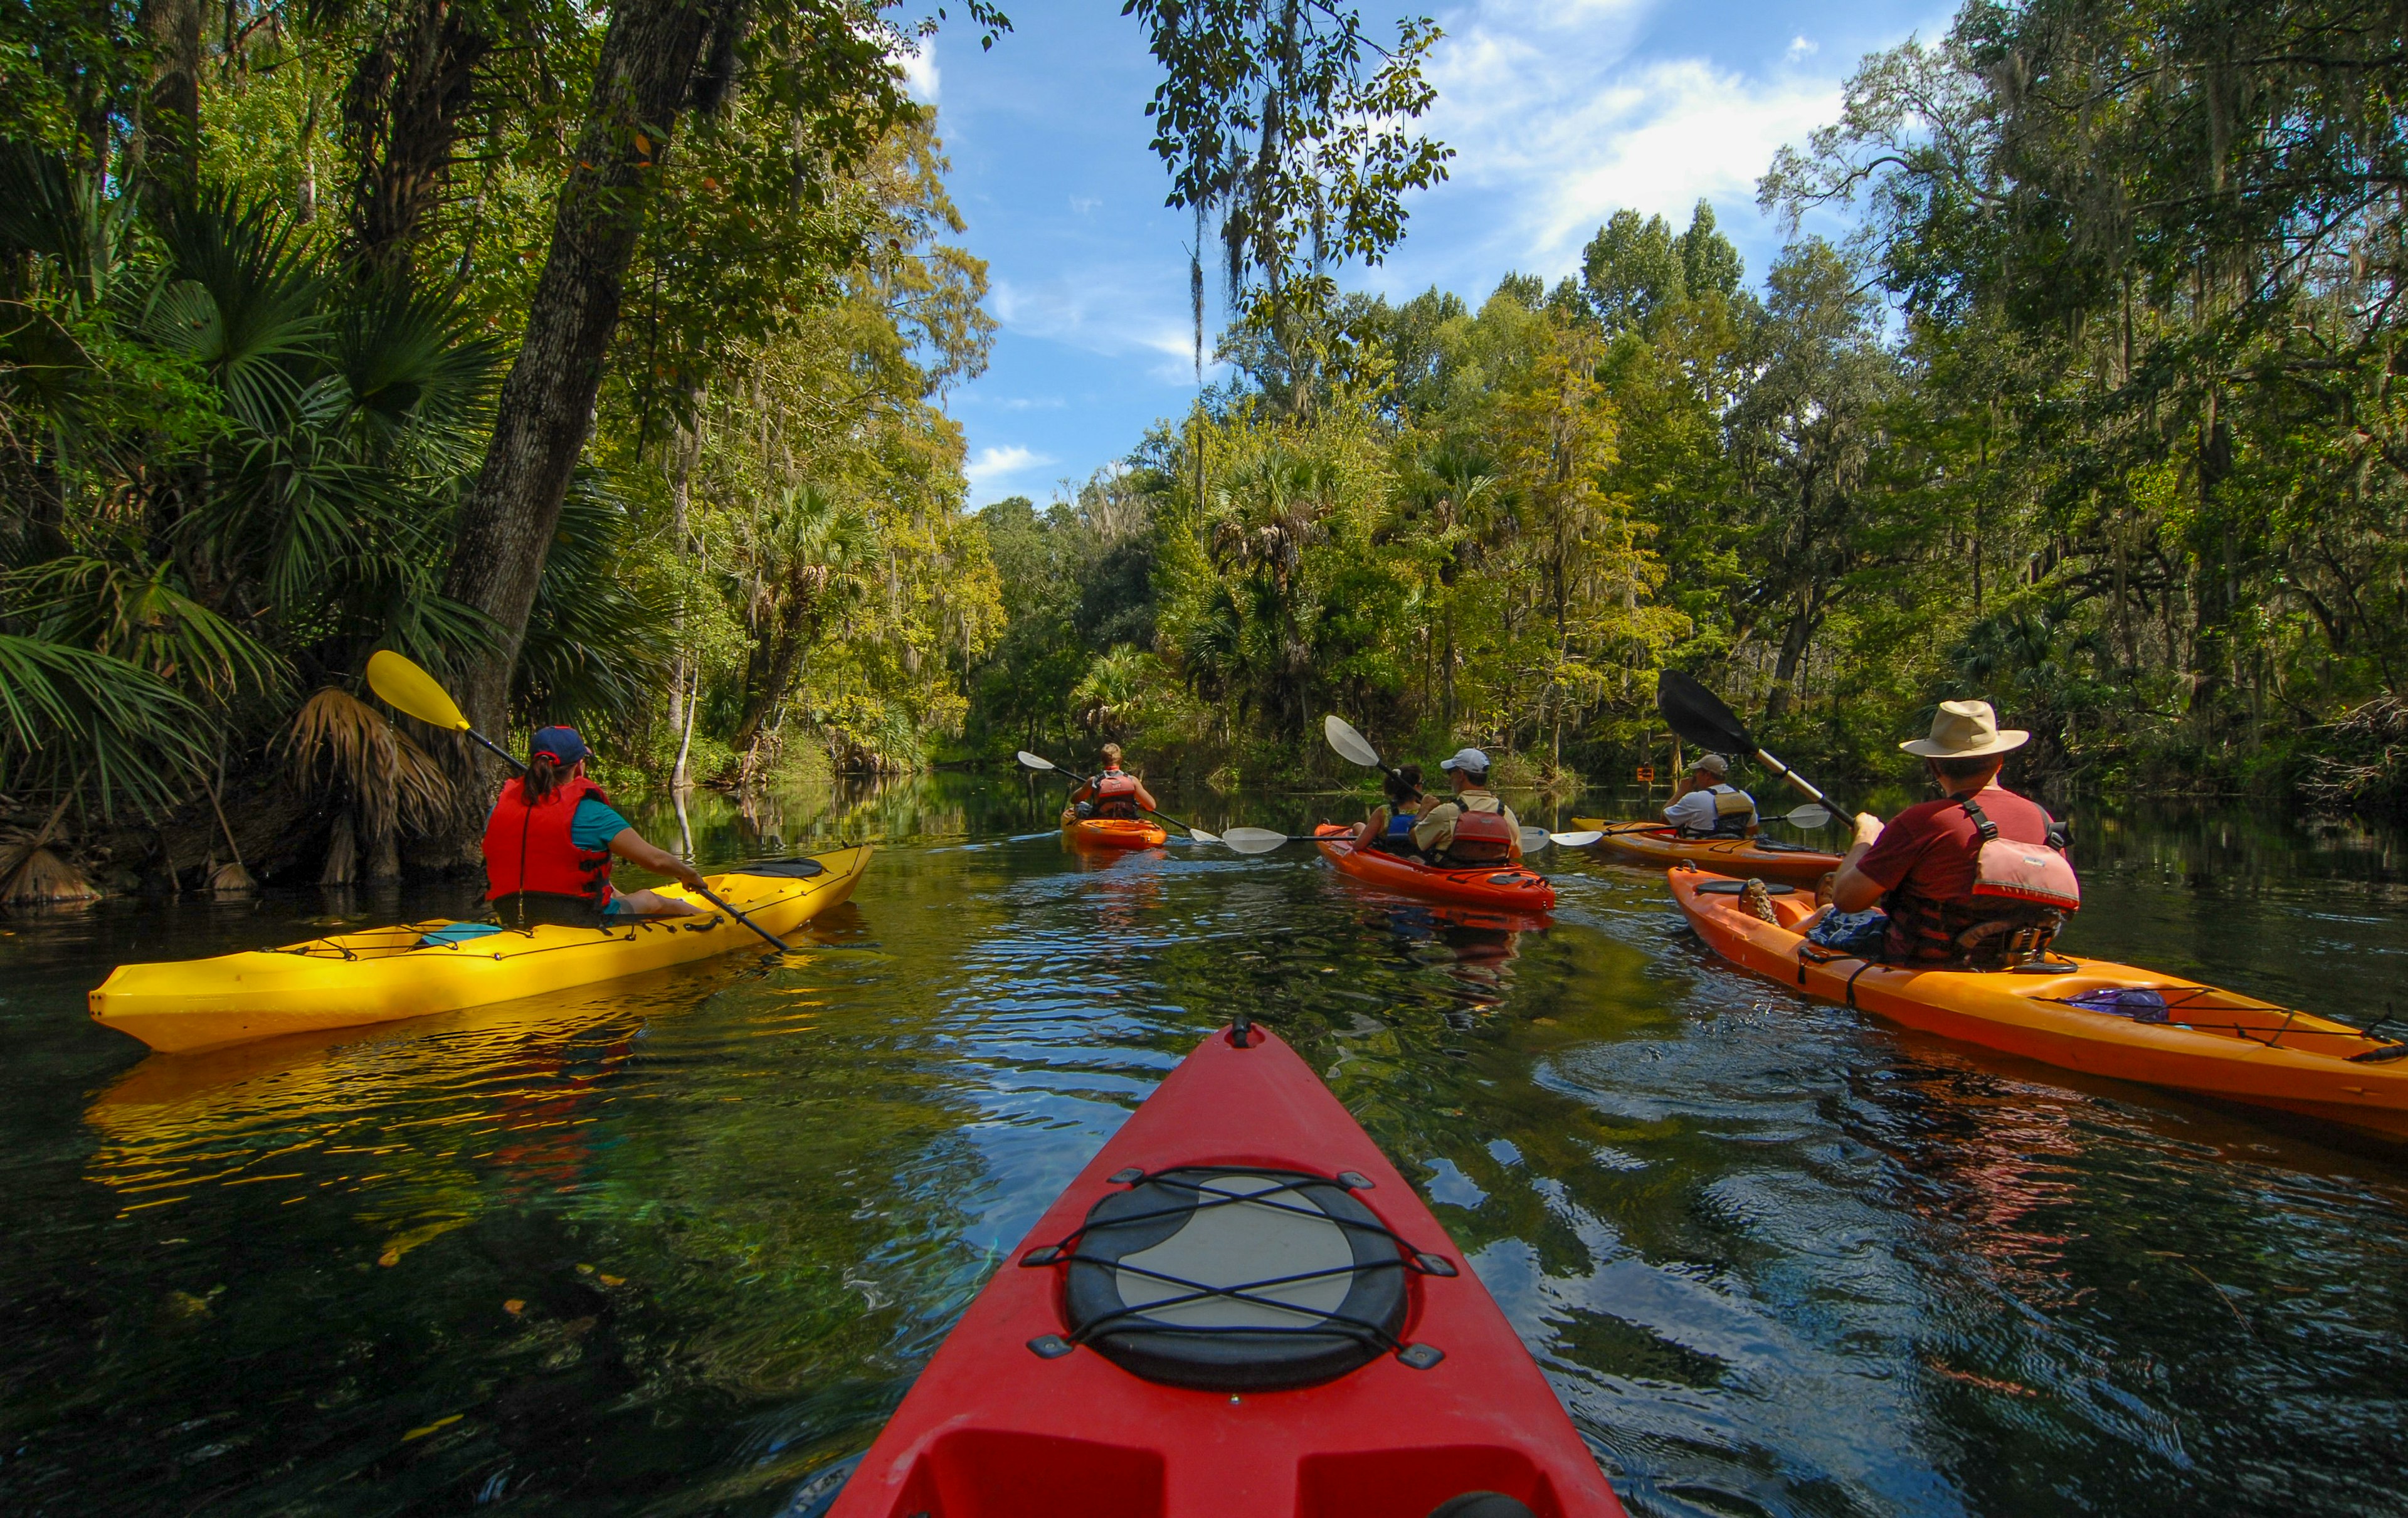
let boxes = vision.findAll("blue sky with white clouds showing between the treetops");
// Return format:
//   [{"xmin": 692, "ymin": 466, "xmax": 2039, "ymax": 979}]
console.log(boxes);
[{"xmin": 911, "ymin": 0, "xmax": 1950, "ymax": 509}]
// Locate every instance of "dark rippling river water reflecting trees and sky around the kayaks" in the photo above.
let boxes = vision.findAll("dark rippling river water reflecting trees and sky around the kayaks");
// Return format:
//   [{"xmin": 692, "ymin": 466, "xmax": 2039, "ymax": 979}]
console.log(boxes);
[{"xmin": 0, "ymin": 776, "xmax": 2408, "ymax": 1518}]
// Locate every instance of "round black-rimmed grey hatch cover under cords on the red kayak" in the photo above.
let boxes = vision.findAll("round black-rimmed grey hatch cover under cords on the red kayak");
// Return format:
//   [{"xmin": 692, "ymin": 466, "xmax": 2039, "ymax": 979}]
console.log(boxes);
[{"xmin": 1021, "ymin": 1166, "xmax": 1454, "ymax": 1390}]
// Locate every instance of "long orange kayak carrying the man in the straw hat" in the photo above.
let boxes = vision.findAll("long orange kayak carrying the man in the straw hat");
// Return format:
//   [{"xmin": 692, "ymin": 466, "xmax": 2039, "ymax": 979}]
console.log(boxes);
[{"xmin": 1669, "ymin": 867, "xmax": 2408, "ymax": 1137}]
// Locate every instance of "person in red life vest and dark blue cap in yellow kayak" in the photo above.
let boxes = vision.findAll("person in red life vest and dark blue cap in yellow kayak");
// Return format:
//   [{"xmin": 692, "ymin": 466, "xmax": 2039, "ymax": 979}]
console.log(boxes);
[{"xmin": 484, "ymin": 728, "xmax": 703, "ymax": 928}]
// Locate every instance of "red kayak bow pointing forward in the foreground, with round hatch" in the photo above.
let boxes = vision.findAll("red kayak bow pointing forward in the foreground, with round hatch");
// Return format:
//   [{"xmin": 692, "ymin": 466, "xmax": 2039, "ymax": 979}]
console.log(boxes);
[{"xmin": 831, "ymin": 1021, "xmax": 1623, "ymax": 1518}]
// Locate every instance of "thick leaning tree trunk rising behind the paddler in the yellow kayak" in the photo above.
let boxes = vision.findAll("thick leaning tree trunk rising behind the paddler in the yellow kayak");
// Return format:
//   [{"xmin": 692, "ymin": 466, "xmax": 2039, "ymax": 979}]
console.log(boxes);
[{"xmin": 429, "ymin": 0, "xmax": 732, "ymax": 867}]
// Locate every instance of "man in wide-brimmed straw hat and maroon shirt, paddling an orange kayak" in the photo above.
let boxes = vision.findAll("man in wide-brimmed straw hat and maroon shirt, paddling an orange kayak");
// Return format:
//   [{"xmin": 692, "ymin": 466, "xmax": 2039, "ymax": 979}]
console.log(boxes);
[{"xmin": 1832, "ymin": 701, "xmax": 2073, "ymax": 964}]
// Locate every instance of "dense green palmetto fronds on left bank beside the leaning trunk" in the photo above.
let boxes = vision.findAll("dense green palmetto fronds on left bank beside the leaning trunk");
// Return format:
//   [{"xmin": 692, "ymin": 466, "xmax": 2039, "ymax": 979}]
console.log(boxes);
[{"xmin": 0, "ymin": 147, "xmax": 496, "ymax": 882}]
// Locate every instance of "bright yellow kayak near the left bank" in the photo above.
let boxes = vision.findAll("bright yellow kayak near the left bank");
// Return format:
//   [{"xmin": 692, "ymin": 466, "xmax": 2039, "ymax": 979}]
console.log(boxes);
[{"xmin": 87, "ymin": 846, "xmax": 877, "ymax": 1053}]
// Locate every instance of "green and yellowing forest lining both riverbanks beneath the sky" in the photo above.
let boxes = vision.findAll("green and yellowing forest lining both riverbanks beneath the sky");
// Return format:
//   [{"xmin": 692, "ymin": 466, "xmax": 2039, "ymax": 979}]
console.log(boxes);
[{"xmin": 0, "ymin": 0, "xmax": 2408, "ymax": 894}]
